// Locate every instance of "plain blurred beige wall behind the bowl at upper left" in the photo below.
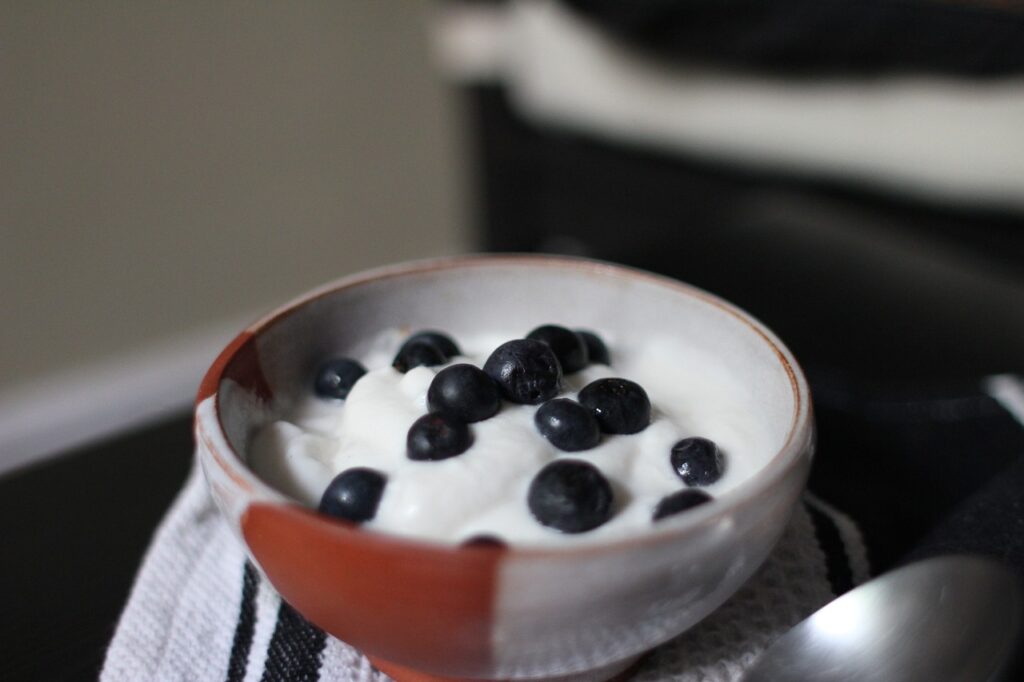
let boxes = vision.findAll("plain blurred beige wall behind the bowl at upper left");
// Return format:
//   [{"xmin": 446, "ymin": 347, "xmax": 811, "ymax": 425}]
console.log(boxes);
[{"xmin": 0, "ymin": 0, "xmax": 469, "ymax": 389}]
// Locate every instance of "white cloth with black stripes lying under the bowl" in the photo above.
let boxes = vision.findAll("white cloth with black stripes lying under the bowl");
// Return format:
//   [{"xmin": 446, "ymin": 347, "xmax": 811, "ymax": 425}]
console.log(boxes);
[{"xmin": 101, "ymin": 462, "xmax": 868, "ymax": 682}]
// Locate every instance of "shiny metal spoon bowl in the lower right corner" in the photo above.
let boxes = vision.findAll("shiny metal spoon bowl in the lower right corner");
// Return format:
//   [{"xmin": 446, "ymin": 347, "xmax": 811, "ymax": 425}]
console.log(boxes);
[{"xmin": 743, "ymin": 556, "xmax": 1024, "ymax": 682}]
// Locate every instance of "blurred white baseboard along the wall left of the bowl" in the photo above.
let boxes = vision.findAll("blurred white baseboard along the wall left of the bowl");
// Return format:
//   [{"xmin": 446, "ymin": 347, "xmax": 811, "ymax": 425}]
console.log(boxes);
[{"xmin": 0, "ymin": 317, "xmax": 252, "ymax": 474}]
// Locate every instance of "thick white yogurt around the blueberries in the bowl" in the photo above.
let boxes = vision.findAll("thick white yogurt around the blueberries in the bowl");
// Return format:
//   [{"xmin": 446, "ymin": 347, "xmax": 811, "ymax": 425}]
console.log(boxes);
[{"xmin": 249, "ymin": 331, "xmax": 773, "ymax": 545}]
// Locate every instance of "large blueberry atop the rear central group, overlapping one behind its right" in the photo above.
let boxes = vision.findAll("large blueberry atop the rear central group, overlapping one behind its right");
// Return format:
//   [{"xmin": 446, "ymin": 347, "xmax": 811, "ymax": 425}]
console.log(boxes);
[{"xmin": 483, "ymin": 339, "xmax": 562, "ymax": 404}]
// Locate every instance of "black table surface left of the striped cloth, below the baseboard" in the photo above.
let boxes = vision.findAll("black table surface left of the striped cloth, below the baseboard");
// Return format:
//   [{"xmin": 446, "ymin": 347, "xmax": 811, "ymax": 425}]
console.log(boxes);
[{"xmin": 0, "ymin": 412, "xmax": 193, "ymax": 680}]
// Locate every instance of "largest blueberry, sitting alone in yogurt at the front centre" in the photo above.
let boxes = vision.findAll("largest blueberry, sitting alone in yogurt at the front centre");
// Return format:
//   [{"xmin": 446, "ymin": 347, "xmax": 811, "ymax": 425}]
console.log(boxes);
[{"xmin": 526, "ymin": 460, "xmax": 612, "ymax": 532}]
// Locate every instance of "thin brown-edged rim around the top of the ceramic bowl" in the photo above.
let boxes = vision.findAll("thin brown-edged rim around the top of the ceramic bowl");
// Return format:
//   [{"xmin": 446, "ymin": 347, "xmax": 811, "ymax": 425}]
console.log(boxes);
[{"xmin": 194, "ymin": 253, "xmax": 814, "ymax": 557}]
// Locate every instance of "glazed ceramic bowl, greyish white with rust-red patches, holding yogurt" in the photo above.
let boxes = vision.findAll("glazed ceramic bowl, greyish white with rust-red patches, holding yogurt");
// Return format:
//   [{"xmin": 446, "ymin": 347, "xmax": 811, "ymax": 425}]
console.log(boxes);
[{"xmin": 196, "ymin": 251, "xmax": 814, "ymax": 680}]
